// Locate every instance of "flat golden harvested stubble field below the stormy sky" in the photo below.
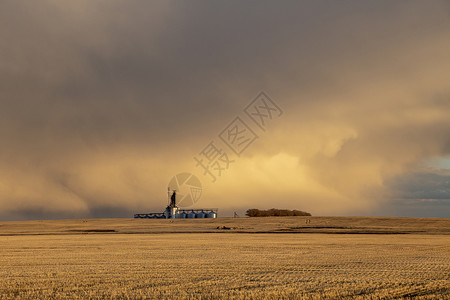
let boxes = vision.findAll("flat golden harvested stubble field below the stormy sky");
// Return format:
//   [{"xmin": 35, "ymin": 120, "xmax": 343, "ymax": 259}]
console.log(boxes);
[{"xmin": 0, "ymin": 217, "xmax": 450, "ymax": 299}]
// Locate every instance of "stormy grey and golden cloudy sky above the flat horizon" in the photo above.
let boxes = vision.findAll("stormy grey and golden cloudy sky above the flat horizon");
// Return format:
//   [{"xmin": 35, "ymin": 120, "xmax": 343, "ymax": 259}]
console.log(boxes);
[{"xmin": 0, "ymin": 0, "xmax": 450, "ymax": 221}]
